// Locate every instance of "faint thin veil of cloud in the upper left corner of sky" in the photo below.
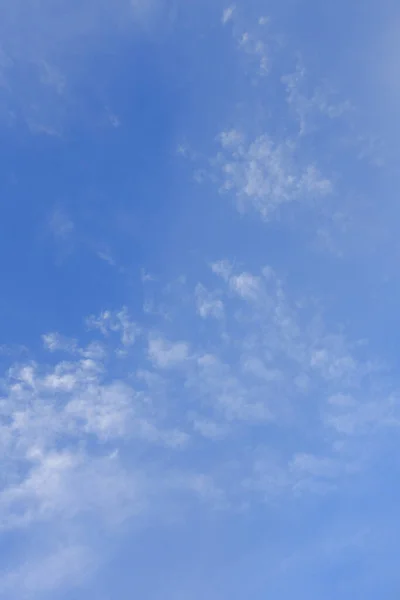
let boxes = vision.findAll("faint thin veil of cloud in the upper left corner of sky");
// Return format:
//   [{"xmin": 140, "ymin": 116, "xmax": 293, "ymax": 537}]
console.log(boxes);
[{"xmin": 0, "ymin": 0, "xmax": 159, "ymax": 136}]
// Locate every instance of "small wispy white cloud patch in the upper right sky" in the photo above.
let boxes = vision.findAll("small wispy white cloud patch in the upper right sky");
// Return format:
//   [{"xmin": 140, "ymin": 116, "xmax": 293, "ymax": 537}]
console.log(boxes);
[{"xmin": 184, "ymin": 5, "xmax": 384, "ymax": 258}]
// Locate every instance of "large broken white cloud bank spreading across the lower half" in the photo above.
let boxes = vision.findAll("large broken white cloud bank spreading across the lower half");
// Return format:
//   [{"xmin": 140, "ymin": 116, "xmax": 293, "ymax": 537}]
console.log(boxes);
[{"xmin": 0, "ymin": 260, "xmax": 400, "ymax": 594}]
